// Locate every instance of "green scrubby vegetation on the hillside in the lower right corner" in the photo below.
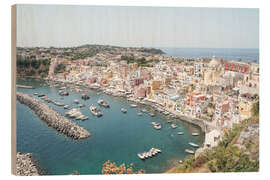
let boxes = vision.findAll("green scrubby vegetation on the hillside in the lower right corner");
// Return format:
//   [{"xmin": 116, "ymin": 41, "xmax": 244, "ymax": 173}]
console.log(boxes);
[{"xmin": 173, "ymin": 104, "xmax": 259, "ymax": 173}]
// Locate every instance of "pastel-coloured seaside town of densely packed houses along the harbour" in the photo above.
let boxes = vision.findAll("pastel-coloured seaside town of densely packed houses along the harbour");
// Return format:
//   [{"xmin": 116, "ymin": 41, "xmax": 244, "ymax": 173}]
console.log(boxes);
[{"xmin": 17, "ymin": 45, "xmax": 259, "ymax": 174}]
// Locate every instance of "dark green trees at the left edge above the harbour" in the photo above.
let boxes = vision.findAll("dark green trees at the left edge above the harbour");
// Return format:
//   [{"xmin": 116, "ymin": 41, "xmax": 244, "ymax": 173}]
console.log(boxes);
[{"xmin": 16, "ymin": 58, "xmax": 50, "ymax": 78}]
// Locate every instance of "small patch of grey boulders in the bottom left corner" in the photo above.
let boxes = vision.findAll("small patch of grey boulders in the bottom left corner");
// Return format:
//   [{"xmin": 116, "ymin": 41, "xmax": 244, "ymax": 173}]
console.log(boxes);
[{"xmin": 16, "ymin": 152, "xmax": 39, "ymax": 176}]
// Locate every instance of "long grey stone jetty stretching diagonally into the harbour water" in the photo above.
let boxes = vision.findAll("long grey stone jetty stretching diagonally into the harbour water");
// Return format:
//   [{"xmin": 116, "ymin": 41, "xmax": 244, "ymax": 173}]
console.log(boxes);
[{"xmin": 16, "ymin": 92, "xmax": 91, "ymax": 139}]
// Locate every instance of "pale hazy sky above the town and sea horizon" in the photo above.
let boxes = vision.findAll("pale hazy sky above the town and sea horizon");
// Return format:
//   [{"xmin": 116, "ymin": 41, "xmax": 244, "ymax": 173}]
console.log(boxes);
[{"xmin": 17, "ymin": 5, "xmax": 259, "ymax": 48}]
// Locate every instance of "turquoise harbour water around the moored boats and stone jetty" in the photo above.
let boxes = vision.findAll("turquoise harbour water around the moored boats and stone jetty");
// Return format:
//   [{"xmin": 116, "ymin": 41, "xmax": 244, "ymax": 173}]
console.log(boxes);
[{"xmin": 16, "ymin": 79, "xmax": 204, "ymax": 174}]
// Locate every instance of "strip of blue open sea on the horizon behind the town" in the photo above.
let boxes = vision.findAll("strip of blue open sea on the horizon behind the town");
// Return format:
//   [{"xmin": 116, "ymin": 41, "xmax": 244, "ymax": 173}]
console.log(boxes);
[{"xmin": 159, "ymin": 48, "xmax": 259, "ymax": 63}]
